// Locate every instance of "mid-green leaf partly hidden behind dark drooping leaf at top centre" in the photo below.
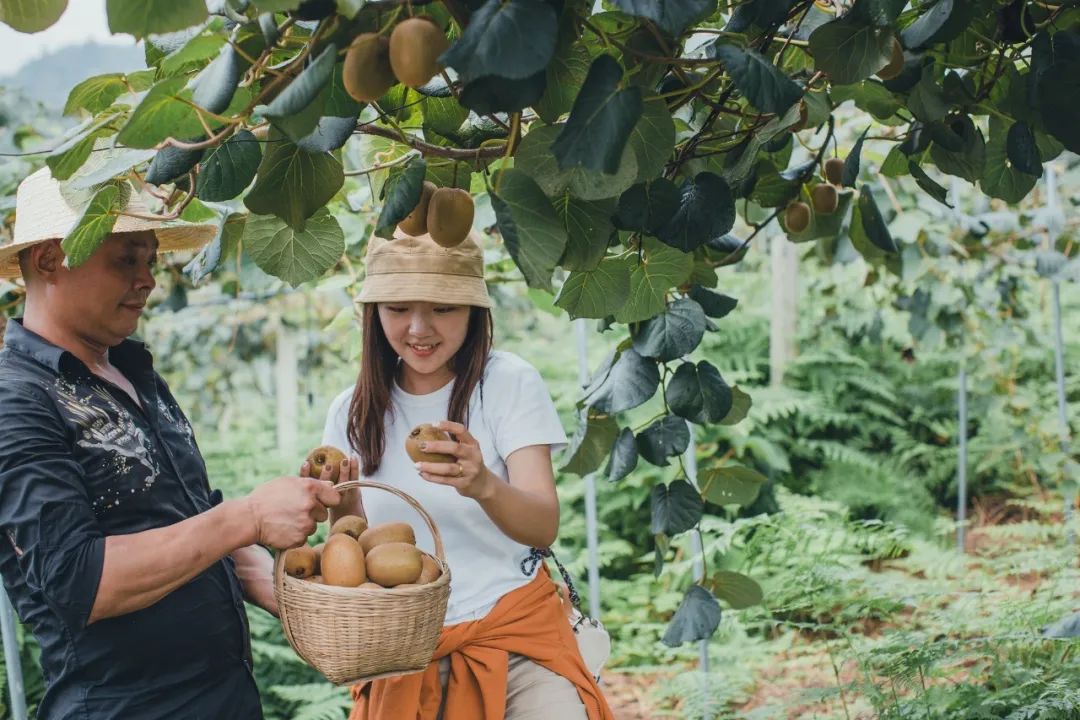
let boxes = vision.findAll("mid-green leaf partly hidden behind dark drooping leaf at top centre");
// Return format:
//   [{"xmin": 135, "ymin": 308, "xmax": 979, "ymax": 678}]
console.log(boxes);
[{"xmin": 514, "ymin": 125, "xmax": 638, "ymax": 200}]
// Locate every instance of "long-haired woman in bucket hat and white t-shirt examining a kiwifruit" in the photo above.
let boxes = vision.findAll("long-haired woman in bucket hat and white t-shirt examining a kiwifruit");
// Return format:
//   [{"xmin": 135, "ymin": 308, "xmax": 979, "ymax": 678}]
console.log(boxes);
[{"xmin": 323, "ymin": 235, "xmax": 611, "ymax": 720}]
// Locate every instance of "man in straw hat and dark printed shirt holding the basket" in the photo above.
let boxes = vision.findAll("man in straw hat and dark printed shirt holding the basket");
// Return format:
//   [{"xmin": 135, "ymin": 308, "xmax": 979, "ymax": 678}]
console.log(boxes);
[{"xmin": 0, "ymin": 171, "xmax": 340, "ymax": 720}]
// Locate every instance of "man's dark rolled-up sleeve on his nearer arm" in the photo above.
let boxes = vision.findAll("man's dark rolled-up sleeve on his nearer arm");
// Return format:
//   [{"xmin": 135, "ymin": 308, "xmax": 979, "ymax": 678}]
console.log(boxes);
[{"xmin": 0, "ymin": 386, "xmax": 105, "ymax": 631}]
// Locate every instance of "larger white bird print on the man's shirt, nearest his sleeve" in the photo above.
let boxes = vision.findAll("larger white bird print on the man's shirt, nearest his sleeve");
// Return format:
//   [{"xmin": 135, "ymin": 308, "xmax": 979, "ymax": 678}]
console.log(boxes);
[{"xmin": 53, "ymin": 379, "xmax": 161, "ymax": 511}]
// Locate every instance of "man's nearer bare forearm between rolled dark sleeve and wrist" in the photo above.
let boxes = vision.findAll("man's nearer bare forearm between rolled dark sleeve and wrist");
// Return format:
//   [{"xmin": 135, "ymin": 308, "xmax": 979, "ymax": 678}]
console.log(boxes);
[{"xmin": 89, "ymin": 500, "xmax": 255, "ymax": 623}]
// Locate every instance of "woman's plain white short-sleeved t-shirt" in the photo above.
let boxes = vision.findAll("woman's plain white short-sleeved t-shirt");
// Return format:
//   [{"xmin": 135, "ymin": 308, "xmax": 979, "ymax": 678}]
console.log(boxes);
[{"xmin": 323, "ymin": 351, "xmax": 566, "ymax": 625}]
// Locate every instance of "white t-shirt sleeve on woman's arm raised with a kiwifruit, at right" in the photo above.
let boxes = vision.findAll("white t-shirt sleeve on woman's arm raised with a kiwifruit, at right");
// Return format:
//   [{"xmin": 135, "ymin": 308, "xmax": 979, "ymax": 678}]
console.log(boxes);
[{"xmin": 490, "ymin": 361, "xmax": 566, "ymax": 458}]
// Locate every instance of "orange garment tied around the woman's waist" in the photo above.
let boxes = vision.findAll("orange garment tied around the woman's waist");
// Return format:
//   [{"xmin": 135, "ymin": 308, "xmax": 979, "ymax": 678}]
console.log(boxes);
[{"xmin": 349, "ymin": 568, "xmax": 615, "ymax": 720}]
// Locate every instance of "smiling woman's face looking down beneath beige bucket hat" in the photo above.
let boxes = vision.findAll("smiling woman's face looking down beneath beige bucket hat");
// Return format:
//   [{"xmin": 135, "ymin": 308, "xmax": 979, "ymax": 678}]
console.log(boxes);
[{"xmin": 378, "ymin": 302, "xmax": 470, "ymax": 376}]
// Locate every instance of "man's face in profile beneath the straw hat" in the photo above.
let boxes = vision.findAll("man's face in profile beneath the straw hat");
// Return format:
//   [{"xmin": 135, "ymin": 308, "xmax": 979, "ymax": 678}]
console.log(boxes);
[{"xmin": 51, "ymin": 231, "xmax": 158, "ymax": 348}]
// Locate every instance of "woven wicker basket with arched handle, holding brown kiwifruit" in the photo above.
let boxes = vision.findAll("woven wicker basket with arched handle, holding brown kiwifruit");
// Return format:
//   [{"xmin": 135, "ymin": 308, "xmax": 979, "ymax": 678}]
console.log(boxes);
[{"xmin": 273, "ymin": 480, "xmax": 450, "ymax": 685}]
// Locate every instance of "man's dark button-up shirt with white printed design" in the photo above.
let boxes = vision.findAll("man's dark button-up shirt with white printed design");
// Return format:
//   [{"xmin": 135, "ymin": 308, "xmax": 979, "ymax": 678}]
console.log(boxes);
[{"xmin": 0, "ymin": 321, "xmax": 262, "ymax": 720}]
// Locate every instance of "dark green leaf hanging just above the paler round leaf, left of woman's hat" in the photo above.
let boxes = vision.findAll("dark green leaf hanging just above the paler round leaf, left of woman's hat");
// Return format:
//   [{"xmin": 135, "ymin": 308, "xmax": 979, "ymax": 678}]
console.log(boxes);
[{"xmin": 244, "ymin": 130, "xmax": 345, "ymax": 232}]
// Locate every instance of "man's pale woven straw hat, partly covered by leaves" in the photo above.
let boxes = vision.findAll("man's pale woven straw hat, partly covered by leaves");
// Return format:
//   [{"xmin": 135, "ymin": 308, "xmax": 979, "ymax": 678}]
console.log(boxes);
[{"xmin": 0, "ymin": 167, "xmax": 218, "ymax": 280}]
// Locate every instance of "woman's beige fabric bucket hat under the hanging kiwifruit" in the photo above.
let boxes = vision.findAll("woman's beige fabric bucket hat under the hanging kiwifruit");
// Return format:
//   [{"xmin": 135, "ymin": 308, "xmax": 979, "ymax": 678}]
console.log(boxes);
[{"xmin": 356, "ymin": 230, "xmax": 491, "ymax": 308}]
